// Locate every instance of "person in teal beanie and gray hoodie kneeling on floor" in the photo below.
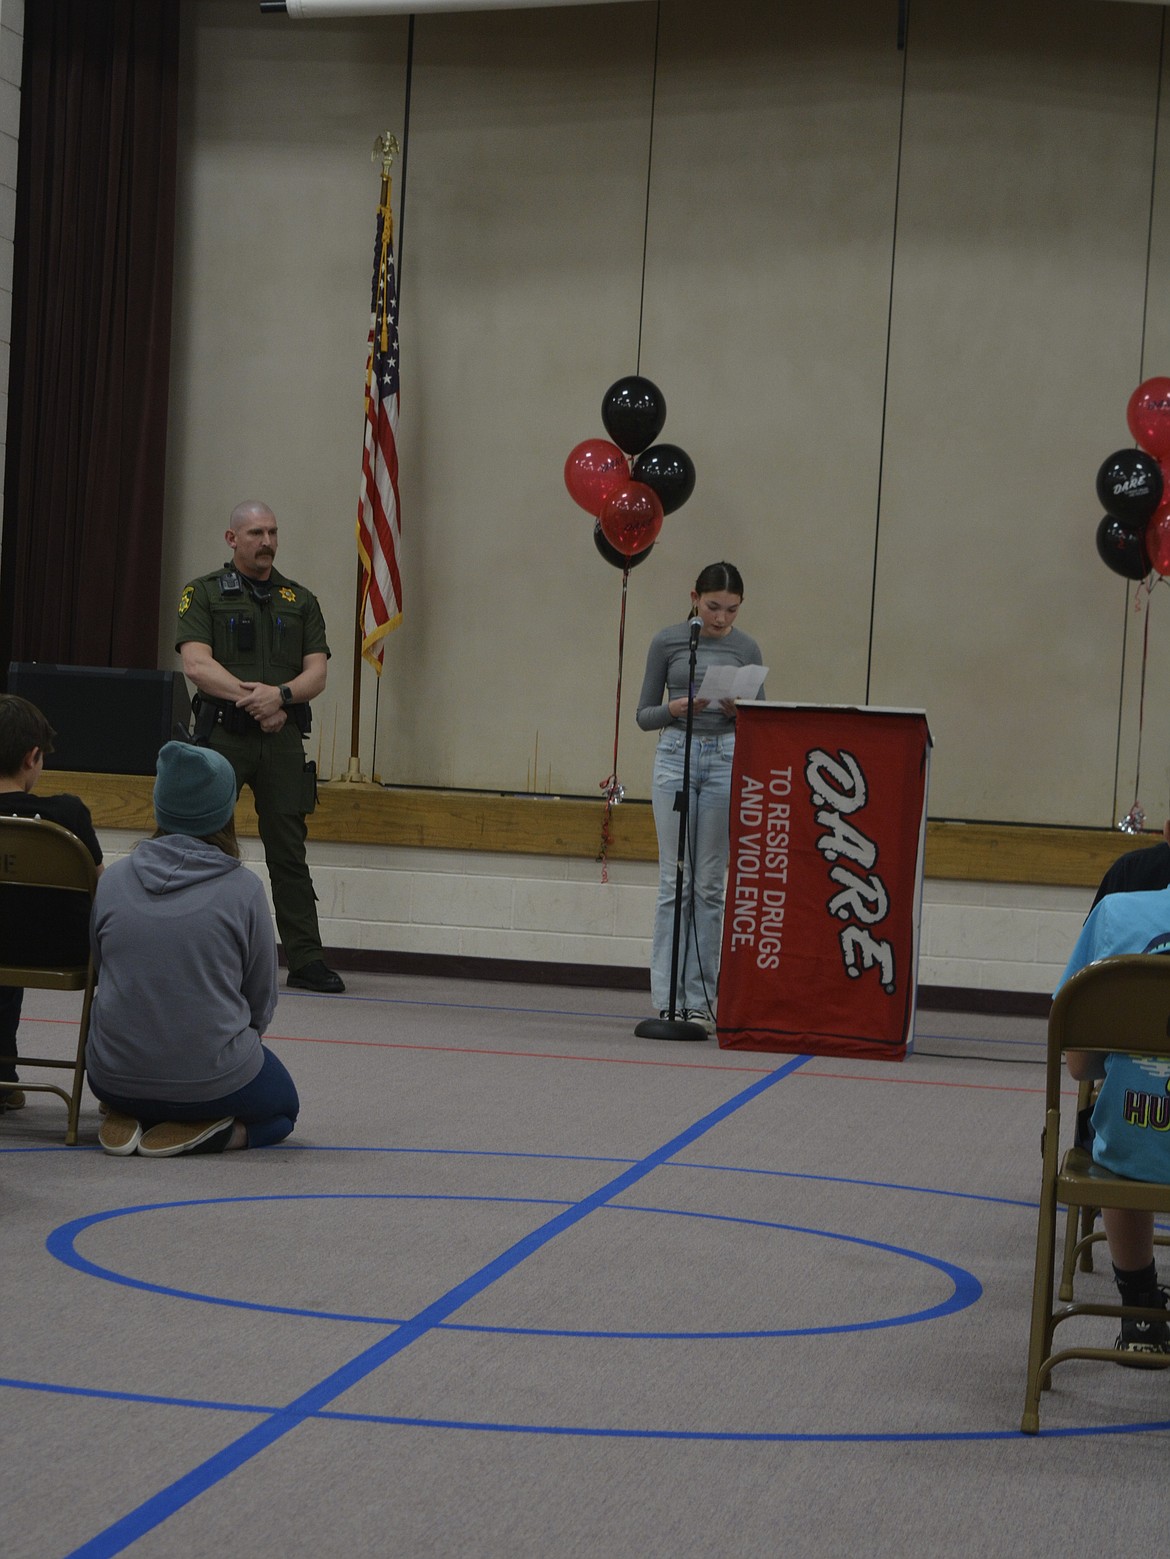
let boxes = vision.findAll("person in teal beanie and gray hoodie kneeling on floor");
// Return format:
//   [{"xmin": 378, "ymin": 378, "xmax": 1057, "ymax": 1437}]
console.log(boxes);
[{"xmin": 86, "ymin": 742, "xmax": 300, "ymax": 1158}]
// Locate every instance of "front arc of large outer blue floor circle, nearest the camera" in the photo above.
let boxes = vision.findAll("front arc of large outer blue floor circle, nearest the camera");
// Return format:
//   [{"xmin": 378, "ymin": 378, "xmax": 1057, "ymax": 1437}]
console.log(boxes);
[{"xmin": 0, "ymin": 1375, "xmax": 1170, "ymax": 1446}]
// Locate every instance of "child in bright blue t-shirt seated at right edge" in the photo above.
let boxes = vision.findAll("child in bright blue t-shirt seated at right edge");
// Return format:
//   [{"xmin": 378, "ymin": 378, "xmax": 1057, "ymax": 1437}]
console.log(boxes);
[{"xmin": 1056, "ymin": 889, "xmax": 1170, "ymax": 1353}]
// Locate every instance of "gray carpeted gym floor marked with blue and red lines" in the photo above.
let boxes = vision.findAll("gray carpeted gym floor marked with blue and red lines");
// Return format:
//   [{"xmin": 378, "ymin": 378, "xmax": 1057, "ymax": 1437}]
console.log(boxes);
[{"xmin": 0, "ymin": 974, "xmax": 1170, "ymax": 1559}]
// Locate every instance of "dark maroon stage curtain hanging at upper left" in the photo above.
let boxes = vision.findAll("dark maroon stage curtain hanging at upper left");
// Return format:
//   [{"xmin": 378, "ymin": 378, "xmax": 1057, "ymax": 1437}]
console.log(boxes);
[{"xmin": 0, "ymin": 0, "xmax": 179, "ymax": 675}]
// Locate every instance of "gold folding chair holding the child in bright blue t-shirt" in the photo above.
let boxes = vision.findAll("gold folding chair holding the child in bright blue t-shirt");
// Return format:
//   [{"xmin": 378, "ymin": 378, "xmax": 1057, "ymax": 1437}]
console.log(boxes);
[{"xmin": 1020, "ymin": 953, "xmax": 1170, "ymax": 1434}]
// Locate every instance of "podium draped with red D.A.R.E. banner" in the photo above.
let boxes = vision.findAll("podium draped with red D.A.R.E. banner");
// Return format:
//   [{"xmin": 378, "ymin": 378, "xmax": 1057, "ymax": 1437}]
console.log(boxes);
[{"xmin": 718, "ymin": 703, "xmax": 931, "ymax": 1060}]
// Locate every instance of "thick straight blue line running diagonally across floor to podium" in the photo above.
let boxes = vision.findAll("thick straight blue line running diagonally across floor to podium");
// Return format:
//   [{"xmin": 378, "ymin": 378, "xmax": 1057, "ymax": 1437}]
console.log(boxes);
[{"xmin": 63, "ymin": 1055, "xmax": 810, "ymax": 1559}]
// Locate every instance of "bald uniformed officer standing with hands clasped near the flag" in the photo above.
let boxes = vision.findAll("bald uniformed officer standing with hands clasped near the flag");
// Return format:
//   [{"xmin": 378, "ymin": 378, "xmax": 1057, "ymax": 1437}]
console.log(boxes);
[{"xmin": 175, "ymin": 502, "xmax": 345, "ymax": 995}]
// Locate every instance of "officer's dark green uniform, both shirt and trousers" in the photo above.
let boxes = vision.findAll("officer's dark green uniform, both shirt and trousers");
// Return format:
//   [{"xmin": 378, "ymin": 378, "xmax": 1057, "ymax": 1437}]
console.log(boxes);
[{"xmin": 175, "ymin": 563, "xmax": 329, "ymax": 970}]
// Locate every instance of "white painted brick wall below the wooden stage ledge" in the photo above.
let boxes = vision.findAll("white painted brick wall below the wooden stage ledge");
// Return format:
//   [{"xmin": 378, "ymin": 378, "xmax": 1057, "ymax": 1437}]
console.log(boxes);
[{"xmin": 93, "ymin": 829, "xmax": 1092, "ymax": 993}]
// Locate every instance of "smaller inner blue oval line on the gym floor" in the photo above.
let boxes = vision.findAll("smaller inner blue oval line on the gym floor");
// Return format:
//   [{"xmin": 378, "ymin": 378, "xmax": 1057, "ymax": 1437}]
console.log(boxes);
[{"xmin": 45, "ymin": 1191, "xmax": 983, "ymax": 1342}]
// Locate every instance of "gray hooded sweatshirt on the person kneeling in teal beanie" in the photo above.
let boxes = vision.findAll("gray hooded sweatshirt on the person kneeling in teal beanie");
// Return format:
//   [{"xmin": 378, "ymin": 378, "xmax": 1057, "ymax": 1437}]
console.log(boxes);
[{"xmin": 86, "ymin": 834, "xmax": 276, "ymax": 1104}]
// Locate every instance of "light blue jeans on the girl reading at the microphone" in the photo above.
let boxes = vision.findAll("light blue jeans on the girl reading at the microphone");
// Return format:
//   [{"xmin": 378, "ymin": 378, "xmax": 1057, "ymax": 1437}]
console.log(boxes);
[{"xmin": 651, "ymin": 730, "xmax": 735, "ymax": 1013}]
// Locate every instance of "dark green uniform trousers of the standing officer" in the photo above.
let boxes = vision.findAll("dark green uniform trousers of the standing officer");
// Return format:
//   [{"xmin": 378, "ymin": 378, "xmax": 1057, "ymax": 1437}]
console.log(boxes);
[{"xmin": 211, "ymin": 720, "xmax": 321, "ymax": 970}]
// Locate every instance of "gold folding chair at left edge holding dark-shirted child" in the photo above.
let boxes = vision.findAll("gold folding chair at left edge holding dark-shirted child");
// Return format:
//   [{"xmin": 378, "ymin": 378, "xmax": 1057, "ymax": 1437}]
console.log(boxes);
[{"xmin": 0, "ymin": 817, "xmax": 97, "ymax": 1147}]
